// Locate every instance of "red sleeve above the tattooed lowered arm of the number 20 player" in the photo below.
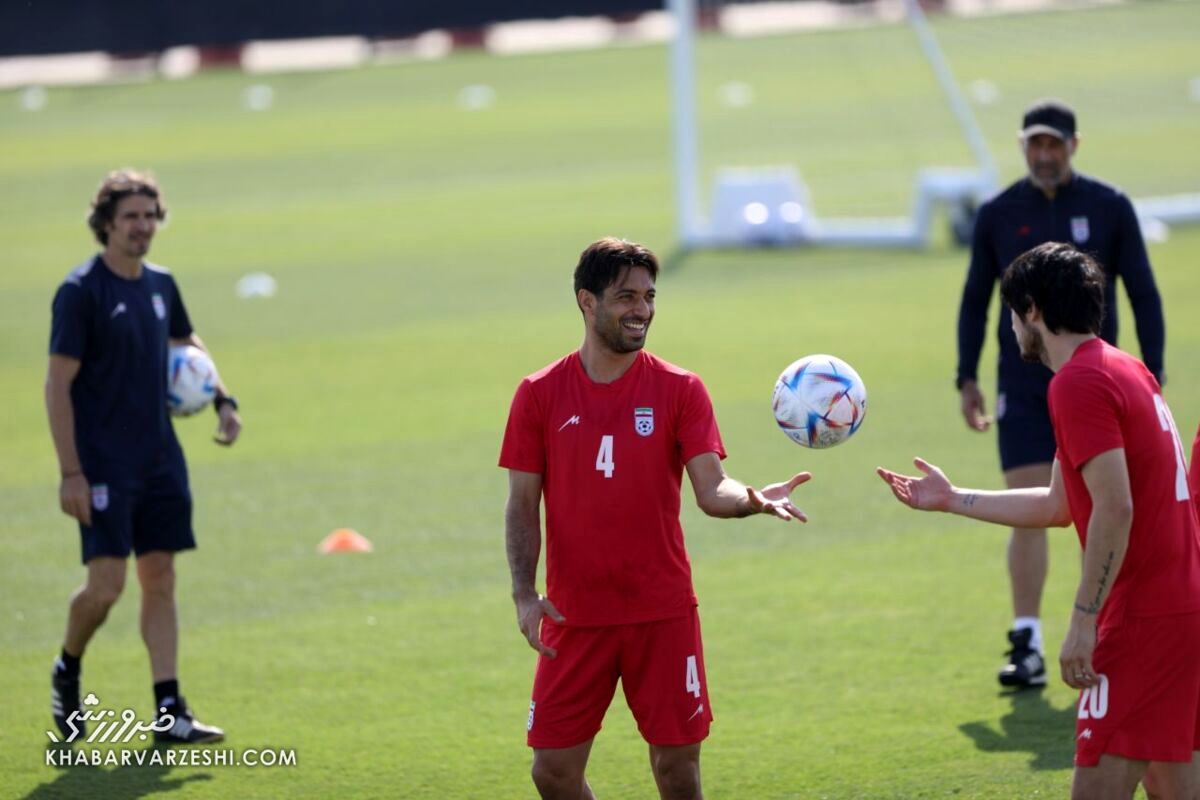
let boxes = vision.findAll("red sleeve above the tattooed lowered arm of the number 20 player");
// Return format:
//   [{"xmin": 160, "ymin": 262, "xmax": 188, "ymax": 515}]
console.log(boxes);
[{"xmin": 1050, "ymin": 371, "xmax": 1124, "ymax": 469}]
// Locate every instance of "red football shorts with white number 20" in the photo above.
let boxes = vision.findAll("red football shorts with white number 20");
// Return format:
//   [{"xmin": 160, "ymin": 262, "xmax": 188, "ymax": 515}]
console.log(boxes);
[{"xmin": 1075, "ymin": 612, "xmax": 1200, "ymax": 766}]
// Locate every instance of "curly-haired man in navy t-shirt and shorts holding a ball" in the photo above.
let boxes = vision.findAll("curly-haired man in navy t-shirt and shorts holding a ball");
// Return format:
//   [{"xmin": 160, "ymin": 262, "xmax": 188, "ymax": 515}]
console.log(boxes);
[{"xmin": 46, "ymin": 170, "xmax": 241, "ymax": 744}]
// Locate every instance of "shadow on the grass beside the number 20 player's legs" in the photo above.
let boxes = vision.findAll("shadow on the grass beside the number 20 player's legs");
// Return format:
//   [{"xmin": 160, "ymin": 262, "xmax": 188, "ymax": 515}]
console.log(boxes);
[{"xmin": 959, "ymin": 690, "xmax": 1075, "ymax": 770}]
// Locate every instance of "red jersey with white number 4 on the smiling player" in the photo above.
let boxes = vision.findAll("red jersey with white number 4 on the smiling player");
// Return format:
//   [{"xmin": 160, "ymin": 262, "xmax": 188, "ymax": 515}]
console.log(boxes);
[{"xmin": 500, "ymin": 350, "xmax": 725, "ymax": 625}]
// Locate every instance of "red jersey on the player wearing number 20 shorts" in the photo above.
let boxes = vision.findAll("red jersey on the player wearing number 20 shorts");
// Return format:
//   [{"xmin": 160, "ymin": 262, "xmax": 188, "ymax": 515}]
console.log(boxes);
[{"xmin": 1049, "ymin": 338, "xmax": 1200, "ymax": 626}]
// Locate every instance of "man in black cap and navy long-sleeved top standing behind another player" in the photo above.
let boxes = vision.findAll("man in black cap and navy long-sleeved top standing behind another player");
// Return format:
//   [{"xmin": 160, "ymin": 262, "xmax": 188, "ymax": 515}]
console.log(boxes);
[{"xmin": 955, "ymin": 100, "xmax": 1165, "ymax": 688}]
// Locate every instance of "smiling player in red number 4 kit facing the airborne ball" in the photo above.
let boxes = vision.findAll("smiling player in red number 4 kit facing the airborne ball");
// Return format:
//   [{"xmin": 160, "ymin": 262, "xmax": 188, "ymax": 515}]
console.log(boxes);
[{"xmin": 499, "ymin": 239, "xmax": 810, "ymax": 800}]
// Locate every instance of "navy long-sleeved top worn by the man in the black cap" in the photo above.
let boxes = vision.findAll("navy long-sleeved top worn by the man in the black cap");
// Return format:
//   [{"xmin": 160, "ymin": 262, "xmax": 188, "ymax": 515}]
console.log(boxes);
[{"xmin": 958, "ymin": 174, "xmax": 1166, "ymax": 393}]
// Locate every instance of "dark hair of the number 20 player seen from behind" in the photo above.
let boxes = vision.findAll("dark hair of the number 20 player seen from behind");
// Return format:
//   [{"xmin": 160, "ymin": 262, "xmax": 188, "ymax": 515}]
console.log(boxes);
[{"xmin": 1000, "ymin": 242, "xmax": 1104, "ymax": 335}]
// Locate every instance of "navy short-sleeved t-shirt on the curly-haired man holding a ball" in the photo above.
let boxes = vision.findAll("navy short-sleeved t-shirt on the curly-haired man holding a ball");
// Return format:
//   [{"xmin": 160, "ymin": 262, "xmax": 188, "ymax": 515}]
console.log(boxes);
[{"xmin": 50, "ymin": 255, "xmax": 192, "ymax": 481}]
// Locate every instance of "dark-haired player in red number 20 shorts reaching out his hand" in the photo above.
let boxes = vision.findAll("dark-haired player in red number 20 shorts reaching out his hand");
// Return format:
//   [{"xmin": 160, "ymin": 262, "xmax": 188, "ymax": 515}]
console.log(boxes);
[{"xmin": 878, "ymin": 242, "xmax": 1200, "ymax": 800}]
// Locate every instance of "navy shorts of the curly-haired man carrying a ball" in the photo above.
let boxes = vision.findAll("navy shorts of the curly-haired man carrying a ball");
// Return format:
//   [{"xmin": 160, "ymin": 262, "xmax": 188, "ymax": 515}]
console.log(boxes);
[{"xmin": 79, "ymin": 462, "xmax": 196, "ymax": 564}]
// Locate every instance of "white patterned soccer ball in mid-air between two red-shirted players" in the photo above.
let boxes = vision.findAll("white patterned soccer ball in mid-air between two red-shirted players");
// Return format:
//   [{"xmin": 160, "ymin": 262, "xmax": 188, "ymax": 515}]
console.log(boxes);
[{"xmin": 772, "ymin": 355, "xmax": 866, "ymax": 449}]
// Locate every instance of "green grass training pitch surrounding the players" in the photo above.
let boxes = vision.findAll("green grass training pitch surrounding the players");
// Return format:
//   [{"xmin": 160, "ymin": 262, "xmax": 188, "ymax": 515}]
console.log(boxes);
[{"xmin": 0, "ymin": 2, "xmax": 1200, "ymax": 800}]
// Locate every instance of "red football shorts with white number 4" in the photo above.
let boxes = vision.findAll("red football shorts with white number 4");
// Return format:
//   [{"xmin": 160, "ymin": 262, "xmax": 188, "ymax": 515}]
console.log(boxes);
[{"xmin": 526, "ymin": 608, "xmax": 713, "ymax": 750}]
